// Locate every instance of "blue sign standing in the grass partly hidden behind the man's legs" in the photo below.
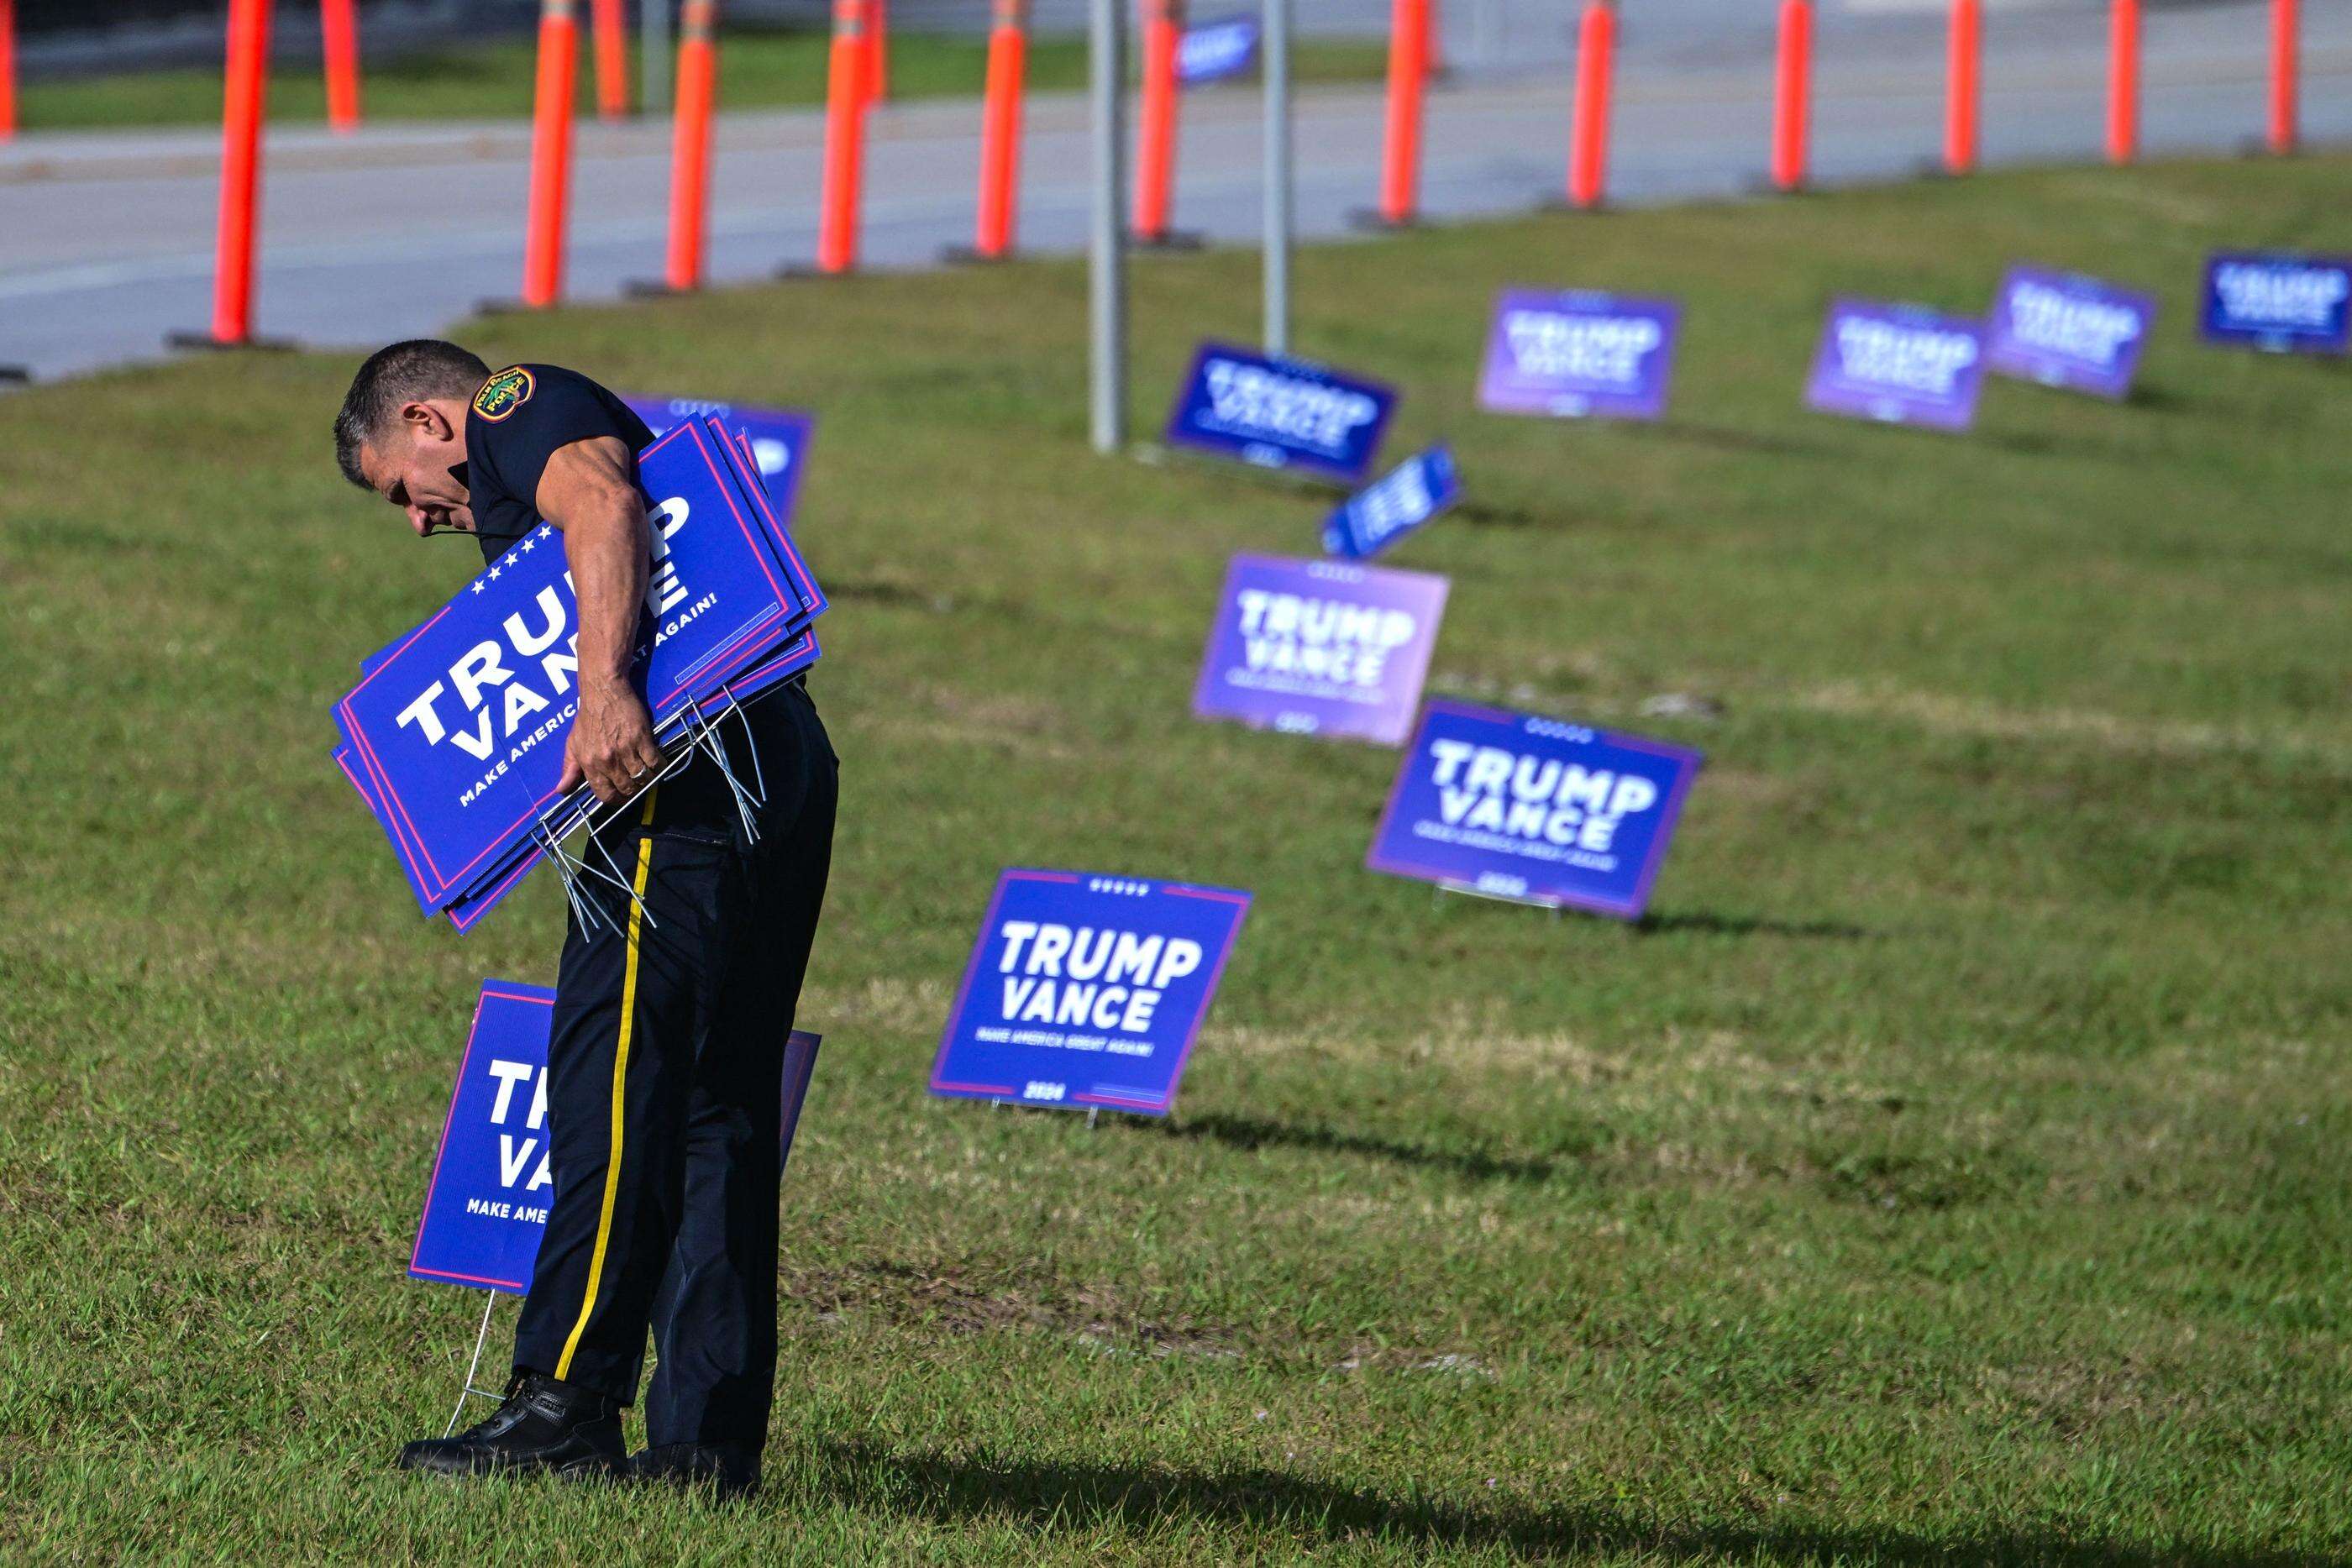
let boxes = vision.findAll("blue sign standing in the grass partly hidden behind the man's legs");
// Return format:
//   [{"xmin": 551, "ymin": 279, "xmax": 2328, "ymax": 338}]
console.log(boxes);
[{"xmin": 409, "ymin": 980, "xmax": 821, "ymax": 1295}]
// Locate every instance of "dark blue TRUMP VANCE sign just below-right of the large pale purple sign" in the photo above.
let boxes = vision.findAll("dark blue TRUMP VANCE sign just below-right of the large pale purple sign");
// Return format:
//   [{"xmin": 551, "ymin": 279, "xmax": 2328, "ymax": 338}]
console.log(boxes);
[{"xmin": 1364, "ymin": 700, "xmax": 1700, "ymax": 919}]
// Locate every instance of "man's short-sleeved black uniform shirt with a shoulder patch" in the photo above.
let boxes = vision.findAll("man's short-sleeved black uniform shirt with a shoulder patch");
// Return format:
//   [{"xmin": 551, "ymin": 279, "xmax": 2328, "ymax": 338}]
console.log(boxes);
[{"xmin": 465, "ymin": 364, "xmax": 654, "ymax": 562}]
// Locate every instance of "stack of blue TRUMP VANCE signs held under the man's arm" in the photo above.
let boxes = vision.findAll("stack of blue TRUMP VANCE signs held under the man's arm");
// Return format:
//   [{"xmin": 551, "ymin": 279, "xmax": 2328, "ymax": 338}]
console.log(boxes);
[{"xmin": 334, "ymin": 416, "xmax": 826, "ymax": 931}]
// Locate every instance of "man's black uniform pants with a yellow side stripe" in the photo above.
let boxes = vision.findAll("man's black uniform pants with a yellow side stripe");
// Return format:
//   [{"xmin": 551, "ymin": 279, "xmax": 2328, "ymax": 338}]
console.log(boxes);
[{"xmin": 515, "ymin": 686, "xmax": 835, "ymax": 1450}]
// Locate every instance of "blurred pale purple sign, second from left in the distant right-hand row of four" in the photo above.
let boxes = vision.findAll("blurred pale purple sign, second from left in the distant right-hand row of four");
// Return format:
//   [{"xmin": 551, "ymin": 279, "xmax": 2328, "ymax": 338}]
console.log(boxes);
[{"xmin": 1804, "ymin": 298, "xmax": 1985, "ymax": 430}]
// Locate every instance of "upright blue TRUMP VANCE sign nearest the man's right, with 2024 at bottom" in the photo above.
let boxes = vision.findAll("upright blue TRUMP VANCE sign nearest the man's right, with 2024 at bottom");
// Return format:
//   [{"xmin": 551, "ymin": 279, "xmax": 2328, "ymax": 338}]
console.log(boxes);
[{"xmin": 932, "ymin": 870, "xmax": 1249, "ymax": 1117}]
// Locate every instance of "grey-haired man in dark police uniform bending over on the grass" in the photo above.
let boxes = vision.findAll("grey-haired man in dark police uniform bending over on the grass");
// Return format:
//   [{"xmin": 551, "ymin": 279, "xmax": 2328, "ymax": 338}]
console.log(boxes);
[{"xmin": 334, "ymin": 341, "xmax": 835, "ymax": 1492}]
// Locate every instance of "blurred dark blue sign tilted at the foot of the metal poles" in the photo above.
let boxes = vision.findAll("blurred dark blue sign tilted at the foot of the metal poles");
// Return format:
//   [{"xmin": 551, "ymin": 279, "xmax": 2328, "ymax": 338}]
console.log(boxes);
[{"xmin": 1167, "ymin": 343, "xmax": 1397, "ymax": 485}]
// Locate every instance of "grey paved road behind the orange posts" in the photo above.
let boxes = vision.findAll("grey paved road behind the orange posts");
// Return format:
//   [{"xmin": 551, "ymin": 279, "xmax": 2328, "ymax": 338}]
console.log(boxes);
[{"xmin": 0, "ymin": 0, "xmax": 2352, "ymax": 379}]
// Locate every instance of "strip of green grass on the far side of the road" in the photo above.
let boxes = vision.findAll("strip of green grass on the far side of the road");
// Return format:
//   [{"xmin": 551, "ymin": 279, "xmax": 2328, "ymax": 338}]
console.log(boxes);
[{"xmin": 18, "ymin": 29, "xmax": 1388, "ymax": 132}]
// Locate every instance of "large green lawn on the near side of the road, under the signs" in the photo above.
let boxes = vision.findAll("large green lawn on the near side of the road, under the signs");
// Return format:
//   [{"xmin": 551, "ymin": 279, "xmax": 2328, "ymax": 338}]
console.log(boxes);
[{"xmin": 0, "ymin": 158, "xmax": 2352, "ymax": 1568}]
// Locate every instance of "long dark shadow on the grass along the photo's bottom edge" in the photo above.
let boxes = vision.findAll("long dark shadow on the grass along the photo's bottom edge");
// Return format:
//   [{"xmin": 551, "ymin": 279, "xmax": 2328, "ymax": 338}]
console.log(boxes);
[{"xmin": 806, "ymin": 1444, "xmax": 2334, "ymax": 1568}]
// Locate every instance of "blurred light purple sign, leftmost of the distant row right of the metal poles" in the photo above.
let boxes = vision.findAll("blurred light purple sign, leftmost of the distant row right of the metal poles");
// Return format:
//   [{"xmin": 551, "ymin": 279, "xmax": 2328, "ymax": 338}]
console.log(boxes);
[{"xmin": 1477, "ymin": 289, "xmax": 1682, "ymax": 418}]
